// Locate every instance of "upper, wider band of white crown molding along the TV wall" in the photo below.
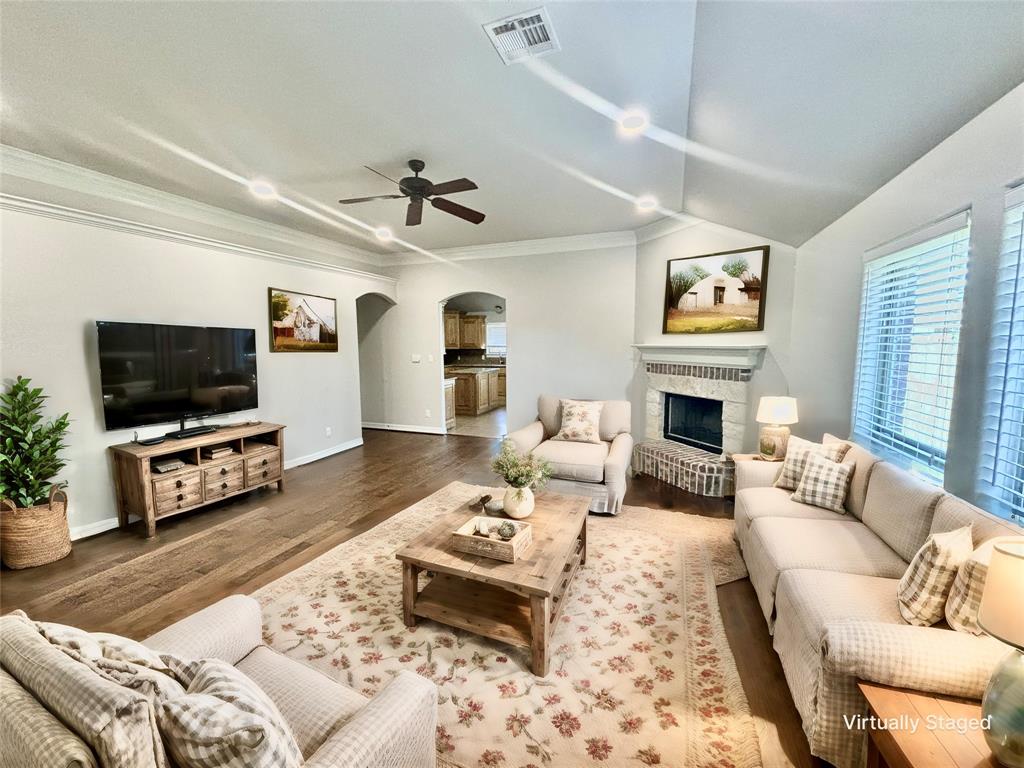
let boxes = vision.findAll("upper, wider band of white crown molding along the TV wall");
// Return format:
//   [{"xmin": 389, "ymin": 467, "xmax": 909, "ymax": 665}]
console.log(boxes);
[{"xmin": 0, "ymin": 144, "xmax": 383, "ymax": 267}]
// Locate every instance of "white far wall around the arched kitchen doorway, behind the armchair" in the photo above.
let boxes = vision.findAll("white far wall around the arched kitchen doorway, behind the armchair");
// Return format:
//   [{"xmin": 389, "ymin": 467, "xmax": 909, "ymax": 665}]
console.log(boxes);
[{"xmin": 372, "ymin": 242, "xmax": 636, "ymax": 431}]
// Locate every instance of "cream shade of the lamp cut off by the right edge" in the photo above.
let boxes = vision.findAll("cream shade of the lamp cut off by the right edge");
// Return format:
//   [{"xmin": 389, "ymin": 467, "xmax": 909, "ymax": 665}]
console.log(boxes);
[{"xmin": 978, "ymin": 538, "xmax": 1024, "ymax": 650}]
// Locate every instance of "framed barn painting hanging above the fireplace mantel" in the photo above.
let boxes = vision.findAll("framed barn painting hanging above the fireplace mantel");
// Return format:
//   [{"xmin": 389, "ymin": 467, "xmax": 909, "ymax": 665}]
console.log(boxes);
[{"xmin": 662, "ymin": 246, "xmax": 768, "ymax": 334}]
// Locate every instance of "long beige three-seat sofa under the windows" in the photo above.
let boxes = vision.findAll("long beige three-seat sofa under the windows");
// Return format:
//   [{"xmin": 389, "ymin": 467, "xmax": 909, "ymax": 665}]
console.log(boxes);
[{"xmin": 735, "ymin": 435, "xmax": 1024, "ymax": 768}]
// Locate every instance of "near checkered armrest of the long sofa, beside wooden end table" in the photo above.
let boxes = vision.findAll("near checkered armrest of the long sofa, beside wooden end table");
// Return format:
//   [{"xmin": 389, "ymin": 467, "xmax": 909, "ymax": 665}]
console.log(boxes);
[{"xmin": 822, "ymin": 621, "xmax": 1011, "ymax": 698}]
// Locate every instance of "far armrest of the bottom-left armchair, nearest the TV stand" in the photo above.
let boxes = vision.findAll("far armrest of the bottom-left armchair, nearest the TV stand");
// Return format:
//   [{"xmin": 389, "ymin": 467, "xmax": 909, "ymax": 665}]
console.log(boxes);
[{"xmin": 142, "ymin": 595, "xmax": 263, "ymax": 666}]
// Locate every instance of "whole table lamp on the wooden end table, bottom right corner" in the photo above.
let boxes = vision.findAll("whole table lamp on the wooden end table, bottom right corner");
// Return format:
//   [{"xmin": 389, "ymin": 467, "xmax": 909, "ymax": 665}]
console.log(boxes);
[{"xmin": 978, "ymin": 538, "xmax": 1024, "ymax": 768}]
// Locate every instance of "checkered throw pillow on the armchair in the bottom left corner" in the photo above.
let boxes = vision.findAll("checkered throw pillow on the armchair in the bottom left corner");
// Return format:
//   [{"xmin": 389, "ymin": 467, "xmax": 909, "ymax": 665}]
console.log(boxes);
[{"xmin": 157, "ymin": 656, "xmax": 302, "ymax": 768}]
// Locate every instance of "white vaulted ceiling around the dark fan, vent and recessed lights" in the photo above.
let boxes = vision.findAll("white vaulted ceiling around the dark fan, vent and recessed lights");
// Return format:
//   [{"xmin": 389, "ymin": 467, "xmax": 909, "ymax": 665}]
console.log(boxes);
[{"xmin": 0, "ymin": 1, "xmax": 1024, "ymax": 251}]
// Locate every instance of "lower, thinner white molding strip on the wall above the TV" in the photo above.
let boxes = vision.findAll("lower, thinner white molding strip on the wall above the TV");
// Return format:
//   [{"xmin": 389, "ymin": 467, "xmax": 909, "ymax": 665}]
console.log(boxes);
[{"xmin": 0, "ymin": 193, "xmax": 398, "ymax": 285}]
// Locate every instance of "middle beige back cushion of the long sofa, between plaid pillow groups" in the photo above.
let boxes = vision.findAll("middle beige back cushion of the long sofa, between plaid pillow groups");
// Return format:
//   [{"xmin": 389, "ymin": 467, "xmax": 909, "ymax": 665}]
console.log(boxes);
[{"xmin": 863, "ymin": 462, "xmax": 937, "ymax": 562}]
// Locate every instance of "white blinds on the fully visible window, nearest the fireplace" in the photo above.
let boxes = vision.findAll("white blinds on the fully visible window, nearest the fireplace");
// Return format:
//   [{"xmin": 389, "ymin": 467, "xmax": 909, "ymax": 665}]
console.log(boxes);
[{"xmin": 853, "ymin": 212, "xmax": 971, "ymax": 483}]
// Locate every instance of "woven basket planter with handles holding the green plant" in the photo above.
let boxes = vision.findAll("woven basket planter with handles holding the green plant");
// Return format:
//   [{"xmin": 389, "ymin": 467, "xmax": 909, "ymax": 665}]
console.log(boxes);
[{"xmin": 0, "ymin": 485, "xmax": 71, "ymax": 568}]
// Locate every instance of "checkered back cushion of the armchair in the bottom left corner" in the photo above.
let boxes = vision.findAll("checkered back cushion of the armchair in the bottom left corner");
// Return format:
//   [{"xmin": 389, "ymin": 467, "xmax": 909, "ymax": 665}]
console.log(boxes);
[{"xmin": 0, "ymin": 615, "xmax": 167, "ymax": 768}]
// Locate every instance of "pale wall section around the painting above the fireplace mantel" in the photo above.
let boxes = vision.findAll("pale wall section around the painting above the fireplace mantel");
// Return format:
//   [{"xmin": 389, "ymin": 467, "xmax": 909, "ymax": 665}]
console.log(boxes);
[{"xmin": 631, "ymin": 222, "xmax": 797, "ymax": 451}]
